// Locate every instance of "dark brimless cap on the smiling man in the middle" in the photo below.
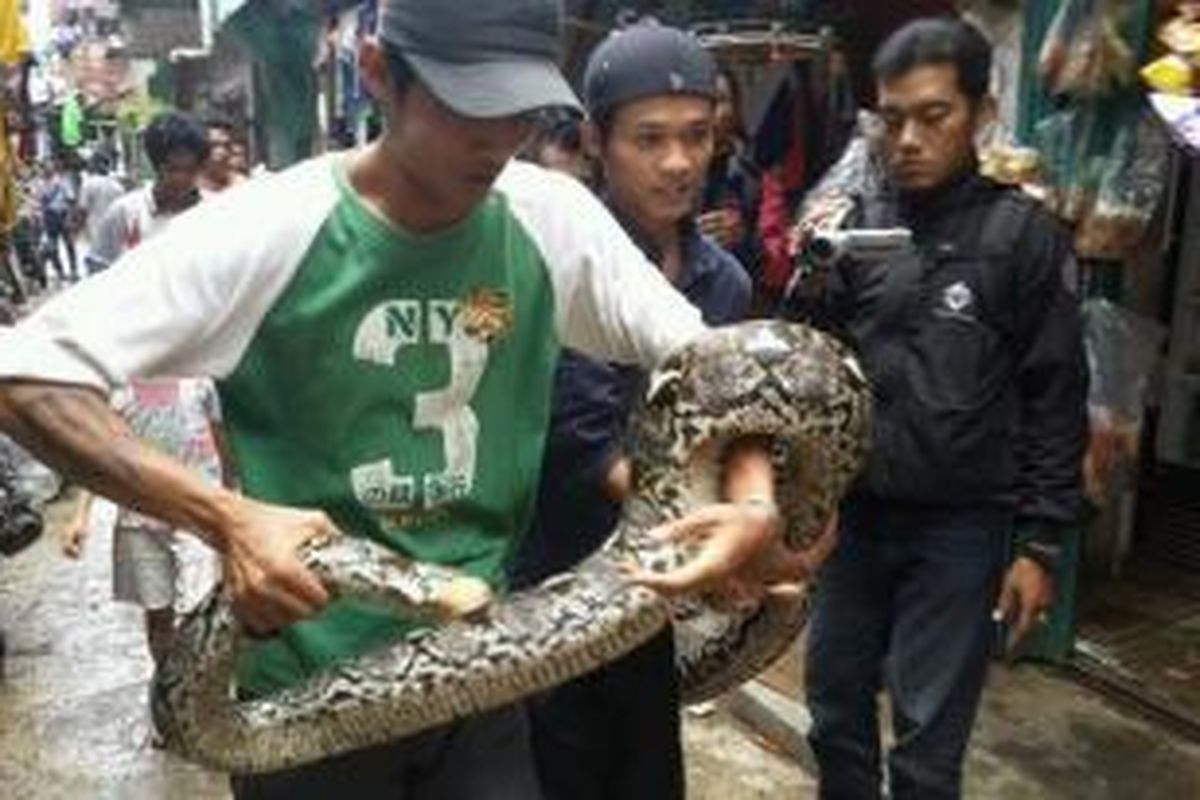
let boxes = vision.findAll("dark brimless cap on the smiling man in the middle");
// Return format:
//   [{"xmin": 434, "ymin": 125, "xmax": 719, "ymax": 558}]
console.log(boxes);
[{"xmin": 583, "ymin": 19, "xmax": 718, "ymax": 119}]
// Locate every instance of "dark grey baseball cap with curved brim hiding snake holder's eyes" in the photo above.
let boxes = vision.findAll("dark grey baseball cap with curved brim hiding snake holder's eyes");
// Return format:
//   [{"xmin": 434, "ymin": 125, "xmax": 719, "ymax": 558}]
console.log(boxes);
[{"xmin": 378, "ymin": 0, "xmax": 580, "ymax": 119}]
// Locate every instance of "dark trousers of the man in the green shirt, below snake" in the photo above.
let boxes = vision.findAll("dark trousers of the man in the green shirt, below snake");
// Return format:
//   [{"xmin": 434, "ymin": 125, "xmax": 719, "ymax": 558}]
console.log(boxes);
[{"xmin": 225, "ymin": 706, "xmax": 541, "ymax": 800}]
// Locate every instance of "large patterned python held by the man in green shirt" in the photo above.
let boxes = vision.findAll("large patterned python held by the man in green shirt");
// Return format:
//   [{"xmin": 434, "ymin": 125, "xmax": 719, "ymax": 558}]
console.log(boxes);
[{"xmin": 152, "ymin": 321, "xmax": 869, "ymax": 772}]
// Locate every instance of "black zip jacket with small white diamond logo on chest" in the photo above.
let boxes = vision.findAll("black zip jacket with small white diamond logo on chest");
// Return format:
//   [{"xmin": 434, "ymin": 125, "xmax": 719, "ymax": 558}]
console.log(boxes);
[{"xmin": 787, "ymin": 175, "xmax": 1087, "ymax": 528}]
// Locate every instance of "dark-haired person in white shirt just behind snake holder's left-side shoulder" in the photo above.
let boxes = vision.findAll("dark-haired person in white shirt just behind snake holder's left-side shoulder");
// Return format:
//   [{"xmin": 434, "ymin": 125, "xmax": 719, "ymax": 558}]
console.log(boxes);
[{"xmin": 89, "ymin": 112, "xmax": 209, "ymax": 272}]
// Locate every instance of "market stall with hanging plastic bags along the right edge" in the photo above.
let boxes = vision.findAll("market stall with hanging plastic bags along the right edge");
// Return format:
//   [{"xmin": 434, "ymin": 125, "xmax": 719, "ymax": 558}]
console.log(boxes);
[{"xmin": 998, "ymin": 0, "xmax": 1200, "ymax": 734}]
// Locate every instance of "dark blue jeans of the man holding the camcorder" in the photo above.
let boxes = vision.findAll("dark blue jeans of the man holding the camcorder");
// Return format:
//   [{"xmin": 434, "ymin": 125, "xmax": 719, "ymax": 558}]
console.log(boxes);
[{"xmin": 806, "ymin": 500, "xmax": 1012, "ymax": 800}]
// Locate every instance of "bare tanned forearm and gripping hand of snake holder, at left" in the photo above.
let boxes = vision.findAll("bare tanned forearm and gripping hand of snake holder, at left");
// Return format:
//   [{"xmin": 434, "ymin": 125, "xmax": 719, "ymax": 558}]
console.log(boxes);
[{"xmin": 0, "ymin": 381, "xmax": 334, "ymax": 631}]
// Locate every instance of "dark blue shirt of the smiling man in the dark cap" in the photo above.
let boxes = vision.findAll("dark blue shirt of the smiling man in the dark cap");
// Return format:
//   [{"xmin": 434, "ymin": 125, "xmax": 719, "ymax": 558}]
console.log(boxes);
[{"xmin": 510, "ymin": 223, "xmax": 751, "ymax": 588}]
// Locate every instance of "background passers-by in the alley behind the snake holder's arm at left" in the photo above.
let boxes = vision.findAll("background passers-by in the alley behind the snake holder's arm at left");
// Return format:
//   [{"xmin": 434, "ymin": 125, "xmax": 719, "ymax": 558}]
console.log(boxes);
[{"xmin": 1, "ymin": 112, "xmax": 255, "ymax": 700}]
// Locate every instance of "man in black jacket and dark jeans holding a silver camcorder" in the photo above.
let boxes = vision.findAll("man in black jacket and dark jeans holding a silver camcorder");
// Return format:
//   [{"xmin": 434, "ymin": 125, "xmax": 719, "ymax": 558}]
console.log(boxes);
[{"xmin": 790, "ymin": 19, "xmax": 1087, "ymax": 800}]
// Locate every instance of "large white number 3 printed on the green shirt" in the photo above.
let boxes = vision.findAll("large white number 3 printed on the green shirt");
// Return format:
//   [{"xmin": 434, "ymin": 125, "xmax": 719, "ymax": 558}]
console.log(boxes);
[{"xmin": 350, "ymin": 300, "xmax": 488, "ymax": 510}]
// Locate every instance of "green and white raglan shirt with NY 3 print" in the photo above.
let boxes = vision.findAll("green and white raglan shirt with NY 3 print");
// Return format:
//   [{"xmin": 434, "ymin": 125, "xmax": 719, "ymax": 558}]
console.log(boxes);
[{"xmin": 0, "ymin": 156, "xmax": 702, "ymax": 692}]
